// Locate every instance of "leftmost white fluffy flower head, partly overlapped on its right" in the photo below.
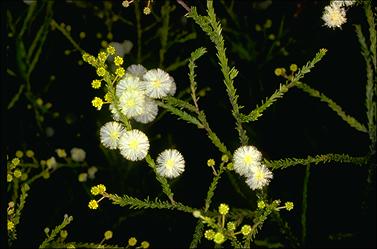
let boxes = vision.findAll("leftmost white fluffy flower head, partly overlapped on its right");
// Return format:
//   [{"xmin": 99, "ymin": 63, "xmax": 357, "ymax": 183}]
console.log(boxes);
[{"xmin": 99, "ymin": 121, "xmax": 124, "ymax": 150}]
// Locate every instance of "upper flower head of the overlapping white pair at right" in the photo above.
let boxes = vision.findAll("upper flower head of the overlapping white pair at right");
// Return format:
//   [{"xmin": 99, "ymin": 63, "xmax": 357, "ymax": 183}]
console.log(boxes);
[{"xmin": 233, "ymin": 145, "xmax": 262, "ymax": 176}]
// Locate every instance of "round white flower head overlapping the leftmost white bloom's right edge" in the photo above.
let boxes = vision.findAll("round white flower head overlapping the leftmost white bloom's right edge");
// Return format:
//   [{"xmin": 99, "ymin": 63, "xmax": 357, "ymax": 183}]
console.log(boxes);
[{"xmin": 119, "ymin": 129, "xmax": 149, "ymax": 161}]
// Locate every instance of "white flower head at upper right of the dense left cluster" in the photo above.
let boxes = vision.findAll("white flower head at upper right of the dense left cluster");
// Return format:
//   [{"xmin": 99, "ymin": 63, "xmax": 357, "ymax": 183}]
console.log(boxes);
[{"xmin": 143, "ymin": 68, "xmax": 174, "ymax": 99}]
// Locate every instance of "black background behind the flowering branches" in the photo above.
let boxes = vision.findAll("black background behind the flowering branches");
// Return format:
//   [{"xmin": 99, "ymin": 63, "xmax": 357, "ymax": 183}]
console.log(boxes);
[{"xmin": 2, "ymin": 0, "xmax": 376, "ymax": 247}]
